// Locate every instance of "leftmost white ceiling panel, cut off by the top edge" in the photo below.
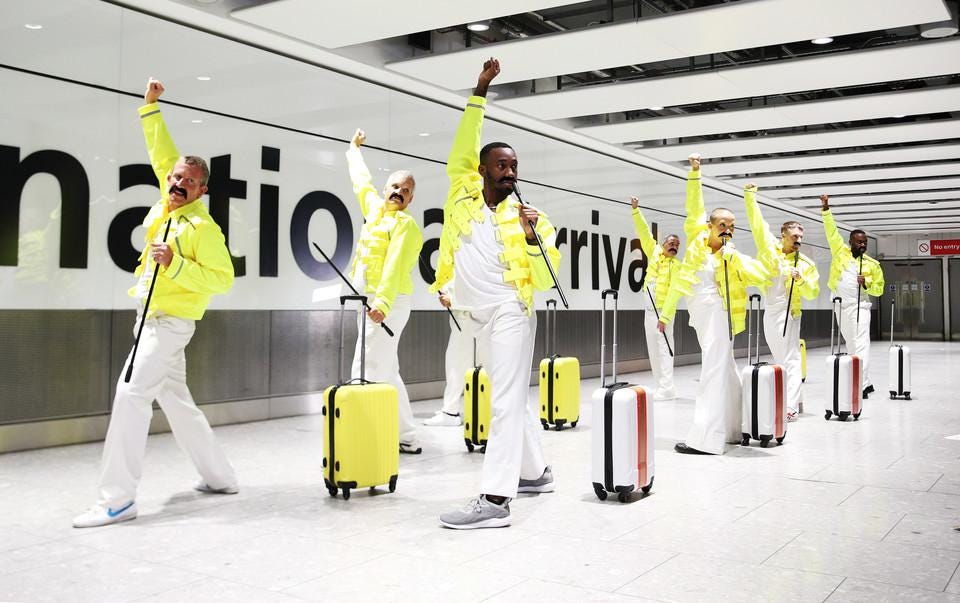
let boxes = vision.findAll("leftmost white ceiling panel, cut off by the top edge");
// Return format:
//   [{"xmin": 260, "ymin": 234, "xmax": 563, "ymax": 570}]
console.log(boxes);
[{"xmin": 230, "ymin": 0, "xmax": 570, "ymax": 48}]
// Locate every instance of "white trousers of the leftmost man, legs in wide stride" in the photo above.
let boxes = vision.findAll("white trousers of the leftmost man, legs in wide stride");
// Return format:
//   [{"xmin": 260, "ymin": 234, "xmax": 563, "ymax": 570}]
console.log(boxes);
[{"xmin": 100, "ymin": 315, "xmax": 237, "ymax": 507}]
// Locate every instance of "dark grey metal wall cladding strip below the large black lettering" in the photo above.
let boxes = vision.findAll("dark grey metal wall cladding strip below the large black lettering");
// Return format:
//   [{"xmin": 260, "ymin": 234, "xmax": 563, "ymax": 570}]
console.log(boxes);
[{"xmin": 0, "ymin": 310, "xmax": 830, "ymax": 423}]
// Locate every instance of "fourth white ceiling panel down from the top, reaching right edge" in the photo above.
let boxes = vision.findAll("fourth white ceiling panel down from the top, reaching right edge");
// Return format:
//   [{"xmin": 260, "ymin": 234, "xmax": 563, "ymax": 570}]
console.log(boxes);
[{"xmin": 576, "ymin": 86, "xmax": 960, "ymax": 142}]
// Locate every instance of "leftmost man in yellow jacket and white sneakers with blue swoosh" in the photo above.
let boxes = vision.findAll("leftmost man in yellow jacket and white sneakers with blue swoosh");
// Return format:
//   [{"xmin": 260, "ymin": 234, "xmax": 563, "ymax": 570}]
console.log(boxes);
[{"xmin": 73, "ymin": 78, "xmax": 237, "ymax": 528}]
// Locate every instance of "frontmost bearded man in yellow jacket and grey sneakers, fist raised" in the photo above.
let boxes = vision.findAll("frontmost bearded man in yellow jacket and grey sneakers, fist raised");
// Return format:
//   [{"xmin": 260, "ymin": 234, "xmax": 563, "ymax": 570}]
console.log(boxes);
[{"xmin": 432, "ymin": 59, "xmax": 560, "ymax": 529}]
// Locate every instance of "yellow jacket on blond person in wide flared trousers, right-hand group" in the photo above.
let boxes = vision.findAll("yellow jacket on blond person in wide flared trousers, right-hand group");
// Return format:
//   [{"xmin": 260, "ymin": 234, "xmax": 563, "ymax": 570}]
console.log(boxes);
[{"xmin": 660, "ymin": 171, "xmax": 767, "ymax": 334}]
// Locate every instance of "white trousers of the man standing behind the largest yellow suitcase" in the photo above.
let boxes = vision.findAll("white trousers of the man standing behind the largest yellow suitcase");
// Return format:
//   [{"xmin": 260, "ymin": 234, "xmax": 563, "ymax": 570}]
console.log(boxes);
[{"xmin": 350, "ymin": 295, "xmax": 417, "ymax": 444}]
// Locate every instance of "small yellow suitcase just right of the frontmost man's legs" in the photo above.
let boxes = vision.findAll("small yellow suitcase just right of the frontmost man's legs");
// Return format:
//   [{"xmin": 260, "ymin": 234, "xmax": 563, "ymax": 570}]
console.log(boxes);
[{"xmin": 540, "ymin": 299, "xmax": 580, "ymax": 431}]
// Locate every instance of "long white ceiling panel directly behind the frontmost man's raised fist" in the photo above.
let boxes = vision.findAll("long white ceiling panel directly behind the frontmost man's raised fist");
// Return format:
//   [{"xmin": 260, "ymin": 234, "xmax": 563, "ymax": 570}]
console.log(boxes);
[{"xmin": 386, "ymin": 0, "xmax": 949, "ymax": 90}]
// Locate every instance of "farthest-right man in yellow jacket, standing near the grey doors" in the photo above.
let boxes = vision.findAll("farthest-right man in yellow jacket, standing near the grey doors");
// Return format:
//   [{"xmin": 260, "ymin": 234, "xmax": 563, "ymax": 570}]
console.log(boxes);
[{"xmin": 820, "ymin": 195, "xmax": 883, "ymax": 399}]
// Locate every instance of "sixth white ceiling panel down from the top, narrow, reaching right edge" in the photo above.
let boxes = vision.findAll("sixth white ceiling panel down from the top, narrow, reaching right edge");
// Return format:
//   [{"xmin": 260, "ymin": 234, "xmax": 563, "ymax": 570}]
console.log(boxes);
[{"xmin": 703, "ymin": 144, "xmax": 960, "ymax": 176}]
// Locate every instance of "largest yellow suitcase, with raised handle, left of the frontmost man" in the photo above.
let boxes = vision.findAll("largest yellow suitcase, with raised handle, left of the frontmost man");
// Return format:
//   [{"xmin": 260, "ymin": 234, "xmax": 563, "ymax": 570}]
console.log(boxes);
[{"xmin": 322, "ymin": 295, "xmax": 400, "ymax": 500}]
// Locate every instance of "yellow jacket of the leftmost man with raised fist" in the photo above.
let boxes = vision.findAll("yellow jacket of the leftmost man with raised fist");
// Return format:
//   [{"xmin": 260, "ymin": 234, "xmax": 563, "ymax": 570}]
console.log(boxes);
[{"xmin": 129, "ymin": 103, "xmax": 233, "ymax": 320}]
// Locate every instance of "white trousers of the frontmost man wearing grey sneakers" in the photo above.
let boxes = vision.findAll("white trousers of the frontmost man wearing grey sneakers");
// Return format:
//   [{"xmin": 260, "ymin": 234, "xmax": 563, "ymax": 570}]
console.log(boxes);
[{"xmin": 473, "ymin": 302, "xmax": 547, "ymax": 498}]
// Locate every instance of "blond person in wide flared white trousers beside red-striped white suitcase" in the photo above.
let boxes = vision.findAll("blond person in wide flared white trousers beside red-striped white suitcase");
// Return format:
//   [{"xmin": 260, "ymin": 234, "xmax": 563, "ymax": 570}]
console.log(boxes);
[{"xmin": 658, "ymin": 155, "xmax": 766, "ymax": 454}]
